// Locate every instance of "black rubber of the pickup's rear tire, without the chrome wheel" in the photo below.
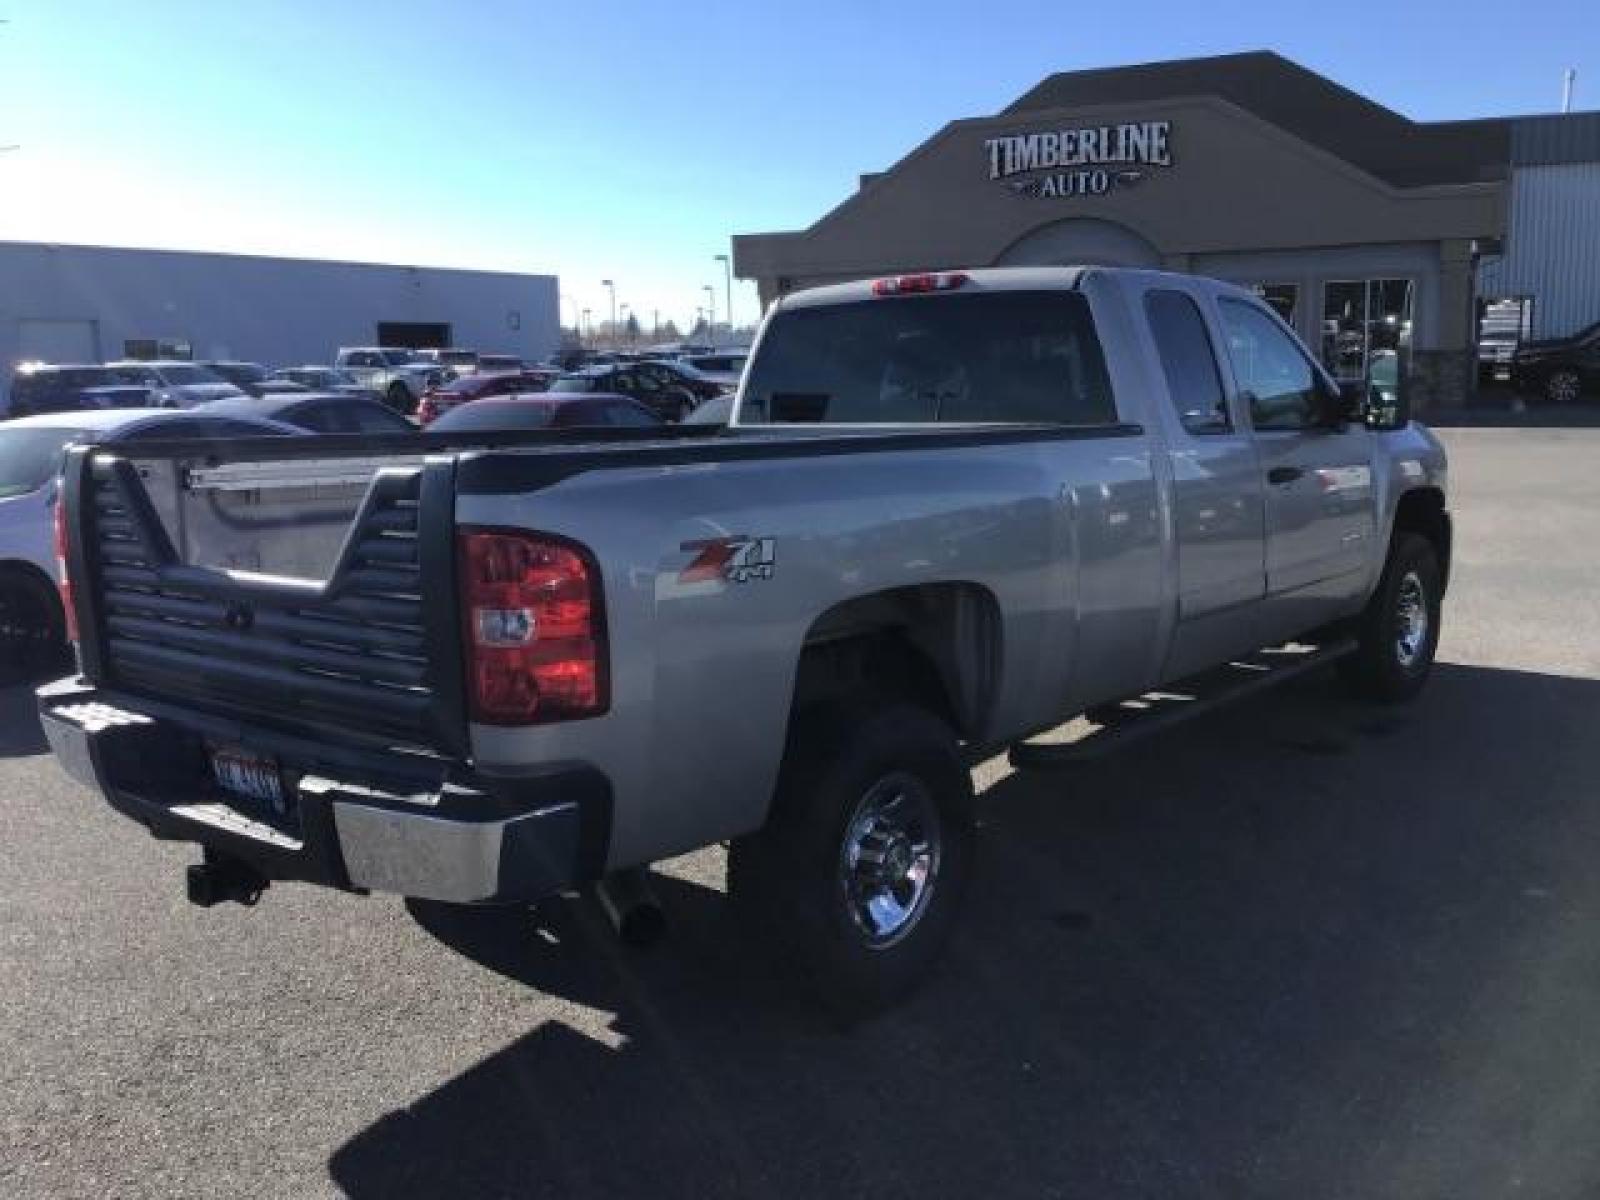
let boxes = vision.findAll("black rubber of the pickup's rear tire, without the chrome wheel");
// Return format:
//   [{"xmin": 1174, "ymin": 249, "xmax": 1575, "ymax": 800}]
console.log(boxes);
[{"xmin": 728, "ymin": 702, "xmax": 973, "ymax": 1019}]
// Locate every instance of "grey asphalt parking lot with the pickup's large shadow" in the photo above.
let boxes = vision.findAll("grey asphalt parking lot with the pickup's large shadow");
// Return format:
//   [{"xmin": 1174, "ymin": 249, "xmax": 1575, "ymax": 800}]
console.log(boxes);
[{"xmin": 0, "ymin": 427, "xmax": 1600, "ymax": 1200}]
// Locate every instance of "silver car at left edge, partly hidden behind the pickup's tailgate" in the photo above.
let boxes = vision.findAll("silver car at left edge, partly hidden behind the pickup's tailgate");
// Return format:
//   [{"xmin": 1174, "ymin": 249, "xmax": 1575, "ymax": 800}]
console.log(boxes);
[{"xmin": 0, "ymin": 408, "xmax": 299, "ymax": 677}]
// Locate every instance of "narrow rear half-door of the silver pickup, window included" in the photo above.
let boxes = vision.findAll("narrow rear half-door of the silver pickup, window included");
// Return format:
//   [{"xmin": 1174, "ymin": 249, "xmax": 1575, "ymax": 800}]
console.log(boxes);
[{"xmin": 1142, "ymin": 286, "xmax": 1267, "ymax": 678}]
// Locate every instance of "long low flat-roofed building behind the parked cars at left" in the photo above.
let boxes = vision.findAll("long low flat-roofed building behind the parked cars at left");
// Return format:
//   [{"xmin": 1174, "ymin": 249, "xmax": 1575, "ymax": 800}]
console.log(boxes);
[{"xmin": 0, "ymin": 242, "xmax": 560, "ymax": 389}]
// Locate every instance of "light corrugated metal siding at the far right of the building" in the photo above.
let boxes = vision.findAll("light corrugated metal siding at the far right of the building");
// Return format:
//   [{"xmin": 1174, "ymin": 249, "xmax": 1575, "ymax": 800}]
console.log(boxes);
[{"xmin": 1478, "ymin": 162, "xmax": 1600, "ymax": 338}]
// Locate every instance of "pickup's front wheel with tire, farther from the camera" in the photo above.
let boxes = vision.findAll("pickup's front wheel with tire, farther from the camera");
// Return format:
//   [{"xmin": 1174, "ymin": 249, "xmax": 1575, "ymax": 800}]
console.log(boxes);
[{"xmin": 1341, "ymin": 531, "xmax": 1443, "ymax": 702}]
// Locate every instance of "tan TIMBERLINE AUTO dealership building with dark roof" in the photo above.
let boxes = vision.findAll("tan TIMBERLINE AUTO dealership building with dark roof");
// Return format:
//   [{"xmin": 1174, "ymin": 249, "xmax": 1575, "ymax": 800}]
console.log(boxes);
[{"xmin": 734, "ymin": 53, "xmax": 1600, "ymax": 410}]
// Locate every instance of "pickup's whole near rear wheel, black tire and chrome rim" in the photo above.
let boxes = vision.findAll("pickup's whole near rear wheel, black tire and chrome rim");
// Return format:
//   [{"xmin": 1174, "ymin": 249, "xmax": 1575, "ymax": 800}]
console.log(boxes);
[{"xmin": 728, "ymin": 701, "xmax": 973, "ymax": 1021}]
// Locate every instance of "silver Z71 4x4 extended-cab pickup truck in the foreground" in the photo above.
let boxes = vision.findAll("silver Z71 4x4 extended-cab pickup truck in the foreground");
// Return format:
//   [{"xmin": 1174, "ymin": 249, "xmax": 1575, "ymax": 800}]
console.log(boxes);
[{"xmin": 38, "ymin": 267, "xmax": 1451, "ymax": 1013}]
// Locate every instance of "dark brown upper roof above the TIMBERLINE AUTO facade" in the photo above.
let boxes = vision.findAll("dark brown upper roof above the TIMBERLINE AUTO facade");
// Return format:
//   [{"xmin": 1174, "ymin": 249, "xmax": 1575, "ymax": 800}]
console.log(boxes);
[{"xmin": 1005, "ymin": 50, "xmax": 1512, "ymax": 187}]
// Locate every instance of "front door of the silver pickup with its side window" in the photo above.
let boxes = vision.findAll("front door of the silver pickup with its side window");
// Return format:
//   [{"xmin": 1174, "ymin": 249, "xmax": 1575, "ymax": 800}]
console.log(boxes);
[{"xmin": 1218, "ymin": 296, "xmax": 1378, "ymax": 642}]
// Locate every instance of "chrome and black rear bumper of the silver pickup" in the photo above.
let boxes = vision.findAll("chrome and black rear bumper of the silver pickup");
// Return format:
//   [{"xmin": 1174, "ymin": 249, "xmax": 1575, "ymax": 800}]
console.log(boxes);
[{"xmin": 38, "ymin": 678, "xmax": 611, "ymax": 904}]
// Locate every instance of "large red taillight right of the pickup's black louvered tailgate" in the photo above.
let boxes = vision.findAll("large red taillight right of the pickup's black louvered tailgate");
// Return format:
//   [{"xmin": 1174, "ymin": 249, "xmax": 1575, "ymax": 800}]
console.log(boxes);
[{"xmin": 458, "ymin": 530, "xmax": 608, "ymax": 725}]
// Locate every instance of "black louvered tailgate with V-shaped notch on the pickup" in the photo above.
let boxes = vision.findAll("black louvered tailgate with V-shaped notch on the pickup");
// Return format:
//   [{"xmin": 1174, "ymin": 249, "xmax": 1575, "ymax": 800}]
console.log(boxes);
[{"xmin": 62, "ymin": 438, "xmax": 467, "ymax": 757}]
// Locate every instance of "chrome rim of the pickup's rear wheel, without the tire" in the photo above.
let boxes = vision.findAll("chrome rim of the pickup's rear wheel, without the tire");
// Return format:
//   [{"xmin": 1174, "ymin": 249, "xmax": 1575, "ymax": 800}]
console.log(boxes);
[{"xmin": 838, "ymin": 771, "xmax": 941, "ymax": 949}]
